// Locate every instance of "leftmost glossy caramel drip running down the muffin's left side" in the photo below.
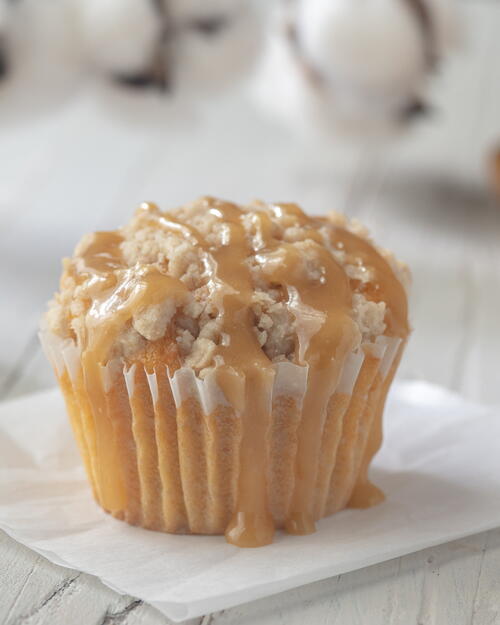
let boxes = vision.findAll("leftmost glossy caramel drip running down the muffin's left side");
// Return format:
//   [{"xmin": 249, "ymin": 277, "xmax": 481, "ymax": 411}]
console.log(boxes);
[{"xmin": 78, "ymin": 222, "xmax": 187, "ymax": 512}]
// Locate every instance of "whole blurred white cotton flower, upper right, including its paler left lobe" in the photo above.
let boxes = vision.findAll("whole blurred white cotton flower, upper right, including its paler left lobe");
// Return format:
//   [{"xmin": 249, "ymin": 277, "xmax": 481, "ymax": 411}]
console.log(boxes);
[{"xmin": 257, "ymin": 0, "xmax": 457, "ymax": 140}]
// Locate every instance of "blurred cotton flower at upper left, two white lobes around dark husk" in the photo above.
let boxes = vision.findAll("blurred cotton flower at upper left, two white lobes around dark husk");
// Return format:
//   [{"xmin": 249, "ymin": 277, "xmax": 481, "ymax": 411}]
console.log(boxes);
[{"xmin": 77, "ymin": 0, "xmax": 261, "ymax": 96}]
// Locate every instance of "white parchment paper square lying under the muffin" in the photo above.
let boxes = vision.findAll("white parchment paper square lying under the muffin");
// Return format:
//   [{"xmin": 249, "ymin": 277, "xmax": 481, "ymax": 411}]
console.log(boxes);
[{"xmin": 0, "ymin": 382, "xmax": 500, "ymax": 621}]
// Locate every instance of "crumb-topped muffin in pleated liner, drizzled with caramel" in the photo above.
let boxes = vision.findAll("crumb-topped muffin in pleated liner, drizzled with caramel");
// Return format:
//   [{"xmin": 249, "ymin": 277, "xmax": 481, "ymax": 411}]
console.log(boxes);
[{"xmin": 40, "ymin": 197, "xmax": 409, "ymax": 547}]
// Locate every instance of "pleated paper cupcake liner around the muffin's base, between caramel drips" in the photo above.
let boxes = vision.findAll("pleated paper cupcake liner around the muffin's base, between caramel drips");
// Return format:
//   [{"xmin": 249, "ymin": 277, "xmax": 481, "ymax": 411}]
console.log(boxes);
[{"xmin": 40, "ymin": 331, "xmax": 404, "ymax": 534}]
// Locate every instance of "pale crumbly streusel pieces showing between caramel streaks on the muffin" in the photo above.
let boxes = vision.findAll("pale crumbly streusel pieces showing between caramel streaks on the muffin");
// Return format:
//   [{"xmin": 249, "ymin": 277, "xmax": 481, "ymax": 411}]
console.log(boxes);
[{"xmin": 45, "ymin": 198, "xmax": 408, "ymax": 374}]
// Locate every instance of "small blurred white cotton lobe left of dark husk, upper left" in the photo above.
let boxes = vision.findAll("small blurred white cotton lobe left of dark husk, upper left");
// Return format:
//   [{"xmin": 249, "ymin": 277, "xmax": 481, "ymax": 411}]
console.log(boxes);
[{"xmin": 80, "ymin": 0, "xmax": 162, "ymax": 75}]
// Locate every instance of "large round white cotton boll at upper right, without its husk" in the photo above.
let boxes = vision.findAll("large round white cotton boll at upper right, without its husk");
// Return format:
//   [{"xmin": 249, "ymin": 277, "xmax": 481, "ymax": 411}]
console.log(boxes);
[{"xmin": 296, "ymin": 0, "xmax": 458, "ymax": 99}]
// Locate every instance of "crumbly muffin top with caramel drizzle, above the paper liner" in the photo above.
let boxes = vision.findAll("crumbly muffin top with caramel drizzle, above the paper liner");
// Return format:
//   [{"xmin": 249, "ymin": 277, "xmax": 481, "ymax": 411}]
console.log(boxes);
[{"xmin": 44, "ymin": 197, "xmax": 409, "ymax": 377}]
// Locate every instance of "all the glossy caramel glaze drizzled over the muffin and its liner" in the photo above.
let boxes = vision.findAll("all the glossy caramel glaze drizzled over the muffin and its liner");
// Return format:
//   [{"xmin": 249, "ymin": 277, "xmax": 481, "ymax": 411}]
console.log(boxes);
[{"xmin": 67, "ymin": 198, "xmax": 408, "ymax": 547}]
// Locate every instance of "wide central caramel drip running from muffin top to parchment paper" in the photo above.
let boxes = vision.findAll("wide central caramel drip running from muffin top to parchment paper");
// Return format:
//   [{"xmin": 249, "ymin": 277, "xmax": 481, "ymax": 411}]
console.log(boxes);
[{"xmin": 199, "ymin": 203, "xmax": 274, "ymax": 547}]
